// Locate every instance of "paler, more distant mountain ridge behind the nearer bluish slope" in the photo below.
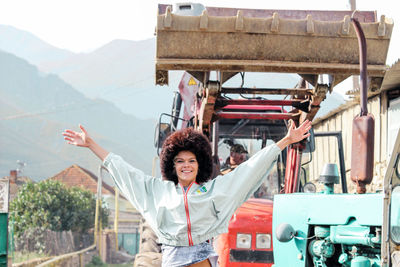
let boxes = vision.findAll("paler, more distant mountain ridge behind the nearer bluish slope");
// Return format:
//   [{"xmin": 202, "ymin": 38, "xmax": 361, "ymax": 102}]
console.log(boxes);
[{"xmin": 0, "ymin": 25, "xmax": 344, "ymax": 119}]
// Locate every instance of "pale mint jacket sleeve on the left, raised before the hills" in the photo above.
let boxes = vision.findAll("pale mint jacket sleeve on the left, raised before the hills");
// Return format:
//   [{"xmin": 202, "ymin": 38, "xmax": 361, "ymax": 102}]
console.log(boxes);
[{"xmin": 103, "ymin": 153, "xmax": 162, "ymax": 214}]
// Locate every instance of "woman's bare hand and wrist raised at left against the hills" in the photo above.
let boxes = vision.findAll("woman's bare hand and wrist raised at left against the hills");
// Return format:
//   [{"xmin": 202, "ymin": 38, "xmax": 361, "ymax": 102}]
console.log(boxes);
[{"xmin": 63, "ymin": 125, "xmax": 109, "ymax": 161}]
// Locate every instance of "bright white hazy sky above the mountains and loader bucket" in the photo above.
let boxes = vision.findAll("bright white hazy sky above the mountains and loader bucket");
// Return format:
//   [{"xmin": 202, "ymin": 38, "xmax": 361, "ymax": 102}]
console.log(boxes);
[{"xmin": 0, "ymin": 0, "xmax": 400, "ymax": 62}]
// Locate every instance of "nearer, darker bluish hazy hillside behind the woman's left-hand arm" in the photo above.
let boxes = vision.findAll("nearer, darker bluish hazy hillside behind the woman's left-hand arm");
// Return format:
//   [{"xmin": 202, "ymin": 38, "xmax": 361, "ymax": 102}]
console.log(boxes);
[{"xmin": 0, "ymin": 52, "xmax": 155, "ymax": 180}]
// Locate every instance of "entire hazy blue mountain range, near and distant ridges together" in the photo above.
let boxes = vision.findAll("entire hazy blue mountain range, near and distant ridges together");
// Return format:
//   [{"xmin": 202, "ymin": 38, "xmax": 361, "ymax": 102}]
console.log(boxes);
[{"xmin": 0, "ymin": 25, "xmax": 344, "ymax": 180}]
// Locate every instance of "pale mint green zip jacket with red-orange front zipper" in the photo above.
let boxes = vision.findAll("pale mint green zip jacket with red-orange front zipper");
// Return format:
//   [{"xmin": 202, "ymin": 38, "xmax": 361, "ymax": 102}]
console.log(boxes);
[{"xmin": 103, "ymin": 144, "xmax": 281, "ymax": 246}]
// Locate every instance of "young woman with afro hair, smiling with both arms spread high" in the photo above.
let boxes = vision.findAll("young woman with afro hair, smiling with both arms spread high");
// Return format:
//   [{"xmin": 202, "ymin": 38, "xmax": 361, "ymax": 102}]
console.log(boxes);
[{"xmin": 63, "ymin": 121, "xmax": 311, "ymax": 267}]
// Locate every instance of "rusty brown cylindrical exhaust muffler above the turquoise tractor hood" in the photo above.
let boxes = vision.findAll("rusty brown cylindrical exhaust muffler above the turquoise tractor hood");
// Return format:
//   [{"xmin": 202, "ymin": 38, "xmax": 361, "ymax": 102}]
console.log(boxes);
[{"xmin": 350, "ymin": 114, "xmax": 375, "ymax": 193}]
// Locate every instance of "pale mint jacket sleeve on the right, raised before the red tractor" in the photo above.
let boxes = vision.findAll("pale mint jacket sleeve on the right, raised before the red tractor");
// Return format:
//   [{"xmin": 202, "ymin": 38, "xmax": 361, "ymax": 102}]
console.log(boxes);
[{"xmin": 210, "ymin": 143, "xmax": 281, "ymax": 214}]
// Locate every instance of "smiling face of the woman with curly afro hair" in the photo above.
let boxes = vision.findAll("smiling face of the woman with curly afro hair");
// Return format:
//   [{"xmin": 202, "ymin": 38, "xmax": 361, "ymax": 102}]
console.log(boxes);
[{"xmin": 174, "ymin": 151, "xmax": 199, "ymax": 186}]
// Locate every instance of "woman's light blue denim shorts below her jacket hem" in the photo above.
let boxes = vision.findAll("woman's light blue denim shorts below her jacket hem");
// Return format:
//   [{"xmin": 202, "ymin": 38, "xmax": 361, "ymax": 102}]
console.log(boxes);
[{"xmin": 161, "ymin": 242, "xmax": 218, "ymax": 267}]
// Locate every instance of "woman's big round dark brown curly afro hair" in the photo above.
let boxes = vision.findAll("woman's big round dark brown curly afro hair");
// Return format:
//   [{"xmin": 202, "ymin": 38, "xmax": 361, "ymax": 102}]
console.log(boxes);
[{"xmin": 160, "ymin": 128, "xmax": 213, "ymax": 184}]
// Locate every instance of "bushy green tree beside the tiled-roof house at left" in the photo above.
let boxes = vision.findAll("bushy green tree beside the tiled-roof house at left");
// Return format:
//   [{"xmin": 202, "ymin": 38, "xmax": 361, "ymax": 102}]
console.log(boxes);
[{"xmin": 10, "ymin": 180, "xmax": 109, "ymax": 251}]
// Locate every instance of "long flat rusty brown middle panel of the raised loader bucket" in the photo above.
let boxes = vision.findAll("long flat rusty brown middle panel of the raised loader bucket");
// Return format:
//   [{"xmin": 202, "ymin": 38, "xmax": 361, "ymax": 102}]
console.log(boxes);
[{"xmin": 156, "ymin": 31, "xmax": 389, "ymax": 64}]
